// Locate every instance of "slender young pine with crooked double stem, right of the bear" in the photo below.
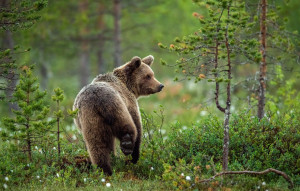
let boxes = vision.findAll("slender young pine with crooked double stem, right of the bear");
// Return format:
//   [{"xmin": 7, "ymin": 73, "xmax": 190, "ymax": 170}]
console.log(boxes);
[{"xmin": 158, "ymin": 0, "xmax": 261, "ymax": 171}]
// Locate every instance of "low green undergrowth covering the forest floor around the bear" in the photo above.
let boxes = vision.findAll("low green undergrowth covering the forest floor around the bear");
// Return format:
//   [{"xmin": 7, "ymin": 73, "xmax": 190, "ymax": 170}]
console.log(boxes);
[{"xmin": 0, "ymin": 104, "xmax": 300, "ymax": 190}]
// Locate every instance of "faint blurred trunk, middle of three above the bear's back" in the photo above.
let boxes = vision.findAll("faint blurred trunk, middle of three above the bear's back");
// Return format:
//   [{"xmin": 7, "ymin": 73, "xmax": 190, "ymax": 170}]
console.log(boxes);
[{"xmin": 97, "ymin": 3, "xmax": 106, "ymax": 74}]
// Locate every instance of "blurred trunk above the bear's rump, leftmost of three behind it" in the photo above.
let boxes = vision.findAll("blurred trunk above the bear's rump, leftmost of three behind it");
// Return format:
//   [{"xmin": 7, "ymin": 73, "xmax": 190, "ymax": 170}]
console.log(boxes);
[{"xmin": 79, "ymin": 0, "xmax": 90, "ymax": 88}]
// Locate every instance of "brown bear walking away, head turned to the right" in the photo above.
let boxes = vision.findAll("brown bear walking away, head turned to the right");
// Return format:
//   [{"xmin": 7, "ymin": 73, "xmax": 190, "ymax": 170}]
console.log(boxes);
[{"xmin": 73, "ymin": 55, "xmax": 164, "ymax": 175}]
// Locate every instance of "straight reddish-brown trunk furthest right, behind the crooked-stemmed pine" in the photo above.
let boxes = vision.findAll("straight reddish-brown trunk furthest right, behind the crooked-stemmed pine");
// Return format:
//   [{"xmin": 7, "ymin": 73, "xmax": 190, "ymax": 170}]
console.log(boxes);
[{"xmin": 257, "ymin": 0, "xmax": 267, "ymax": 119}]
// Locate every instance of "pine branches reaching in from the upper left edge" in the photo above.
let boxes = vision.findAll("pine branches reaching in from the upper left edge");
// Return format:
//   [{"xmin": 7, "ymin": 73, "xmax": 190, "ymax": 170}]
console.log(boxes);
[{"xmin": 0, "ymin": 0, "xmax": 47, "ymax": 112}]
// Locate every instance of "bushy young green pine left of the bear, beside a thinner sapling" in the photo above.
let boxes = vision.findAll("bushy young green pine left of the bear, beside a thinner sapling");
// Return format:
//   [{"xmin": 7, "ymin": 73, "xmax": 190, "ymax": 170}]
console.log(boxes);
[{"xmin": 2, "ymin": 66, "xmax": 53, "ymax": 161}]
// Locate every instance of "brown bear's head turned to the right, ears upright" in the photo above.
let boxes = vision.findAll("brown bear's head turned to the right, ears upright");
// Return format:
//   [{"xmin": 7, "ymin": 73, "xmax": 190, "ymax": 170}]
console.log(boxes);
[{"xmin": 113, "ymin": 55, "xmax": 164, "ymax": 97}]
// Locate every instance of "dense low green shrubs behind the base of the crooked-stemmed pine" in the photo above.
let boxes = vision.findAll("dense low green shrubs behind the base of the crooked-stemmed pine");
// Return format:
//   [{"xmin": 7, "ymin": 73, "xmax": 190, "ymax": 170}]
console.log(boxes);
[{"xmin": 165, "ymin": 112, "xmax": 300, "ymax": 185}]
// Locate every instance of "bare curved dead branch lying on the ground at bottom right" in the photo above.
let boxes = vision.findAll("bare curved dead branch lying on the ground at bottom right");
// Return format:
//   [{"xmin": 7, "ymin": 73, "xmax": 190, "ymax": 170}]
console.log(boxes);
[{"xmin": 199, "ymin": 168, "xmax": 294, "ymax": 189}]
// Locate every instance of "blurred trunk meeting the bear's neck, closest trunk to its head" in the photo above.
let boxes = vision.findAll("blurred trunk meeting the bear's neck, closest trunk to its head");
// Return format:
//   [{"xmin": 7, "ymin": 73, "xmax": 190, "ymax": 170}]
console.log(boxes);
[{"xmin": 113, "ymin": 0, "xmax": 122, "ymax": 67}]
